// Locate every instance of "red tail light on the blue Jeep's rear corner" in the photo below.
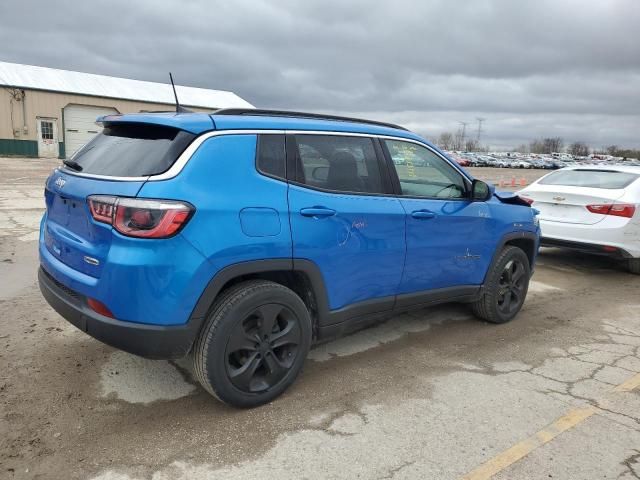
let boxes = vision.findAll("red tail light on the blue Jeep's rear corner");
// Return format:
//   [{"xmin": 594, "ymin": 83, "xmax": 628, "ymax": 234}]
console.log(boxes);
[{"xmin": 88, "ymin": 195, "xmax": 194, "ymax": 238}]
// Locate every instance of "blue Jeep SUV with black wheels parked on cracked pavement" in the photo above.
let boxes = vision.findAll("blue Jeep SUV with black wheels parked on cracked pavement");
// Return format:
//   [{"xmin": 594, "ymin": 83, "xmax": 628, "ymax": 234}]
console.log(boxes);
[{"xmin": 39, "ymin": 109, "xmax": 539, "ymax": 407}]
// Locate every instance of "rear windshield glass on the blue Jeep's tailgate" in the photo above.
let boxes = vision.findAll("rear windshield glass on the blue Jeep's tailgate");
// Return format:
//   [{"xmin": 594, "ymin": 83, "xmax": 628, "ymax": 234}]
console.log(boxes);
[{"xmin": 67, "ymin": 124, "xmax": 195, "ymax": 177}]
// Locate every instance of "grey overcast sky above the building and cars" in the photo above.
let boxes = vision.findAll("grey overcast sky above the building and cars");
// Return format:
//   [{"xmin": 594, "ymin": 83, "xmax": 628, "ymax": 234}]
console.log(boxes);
[{"xmin": 0, "ymin": 0, "xmax": 640, "ymax": 148}]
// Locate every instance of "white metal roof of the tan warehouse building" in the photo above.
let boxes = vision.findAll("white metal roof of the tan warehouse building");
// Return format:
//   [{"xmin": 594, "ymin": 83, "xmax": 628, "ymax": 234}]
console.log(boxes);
[{"xmin": 0, "ymin": 62, "xmax": 253, "ymax": 109}]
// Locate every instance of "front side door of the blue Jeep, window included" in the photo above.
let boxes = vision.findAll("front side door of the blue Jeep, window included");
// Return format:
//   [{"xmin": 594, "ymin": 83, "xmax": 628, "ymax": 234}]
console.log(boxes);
[{"xmin": 383, "ymin": 140, "xmax": 495, "ymax": 294}]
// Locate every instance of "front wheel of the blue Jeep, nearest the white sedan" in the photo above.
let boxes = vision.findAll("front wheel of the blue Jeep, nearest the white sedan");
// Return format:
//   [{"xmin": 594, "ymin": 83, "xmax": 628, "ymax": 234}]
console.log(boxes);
[{"xmin": 471, "ymin": 246, "xmax": 531, "ymax": 323}]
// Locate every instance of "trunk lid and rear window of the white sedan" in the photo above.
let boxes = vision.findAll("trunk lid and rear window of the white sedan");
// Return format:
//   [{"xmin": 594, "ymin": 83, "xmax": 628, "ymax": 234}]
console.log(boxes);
[{"xmin": 522, "ymin": 169, "xmax": 638, "ymax": 225}]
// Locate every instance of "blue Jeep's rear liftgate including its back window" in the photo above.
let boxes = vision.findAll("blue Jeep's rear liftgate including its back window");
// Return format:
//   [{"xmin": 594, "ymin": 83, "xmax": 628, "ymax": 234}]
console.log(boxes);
[{"xmin": 44, "ymin": 123, "xmax": 195, "ymax": 277}]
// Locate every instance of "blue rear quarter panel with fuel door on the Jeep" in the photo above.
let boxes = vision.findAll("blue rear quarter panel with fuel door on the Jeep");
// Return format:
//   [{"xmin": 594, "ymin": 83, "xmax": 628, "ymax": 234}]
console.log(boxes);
[{"xmin": 139, "ymin": 134, "xmax": 292, "ymax": 282}]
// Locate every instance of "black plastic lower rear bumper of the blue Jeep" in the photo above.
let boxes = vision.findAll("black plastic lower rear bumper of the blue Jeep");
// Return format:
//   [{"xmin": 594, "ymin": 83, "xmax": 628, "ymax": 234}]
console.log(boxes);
[{"xmin": 38, "ymin": 267, "xmax": 202, "ymax": 359}]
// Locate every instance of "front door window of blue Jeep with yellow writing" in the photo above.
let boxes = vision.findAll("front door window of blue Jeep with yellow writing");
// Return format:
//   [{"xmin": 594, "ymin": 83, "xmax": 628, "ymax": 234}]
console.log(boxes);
[{"xmin": 384, "ymin": 140, "xmax": 466, "ymax": 198}]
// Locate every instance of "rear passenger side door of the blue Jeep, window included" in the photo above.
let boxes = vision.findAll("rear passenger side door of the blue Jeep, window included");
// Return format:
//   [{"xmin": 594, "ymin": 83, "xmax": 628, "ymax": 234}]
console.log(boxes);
[{"xmin": 287, "ymin": 134, "xmax": 405, "ymax": 311}]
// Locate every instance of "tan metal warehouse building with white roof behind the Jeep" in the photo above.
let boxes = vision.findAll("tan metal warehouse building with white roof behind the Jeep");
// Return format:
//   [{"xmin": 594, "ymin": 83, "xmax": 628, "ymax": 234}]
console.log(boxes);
[{"xmin": 0, "ymin": 62, "xmax": 252, "ymax": 158}]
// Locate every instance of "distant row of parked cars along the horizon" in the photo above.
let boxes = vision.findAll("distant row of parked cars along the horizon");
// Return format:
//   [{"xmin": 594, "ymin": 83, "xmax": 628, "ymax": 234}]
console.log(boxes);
[{"xmin": 447, "ymin": 152, "xmax": 640, "ymax": 170}]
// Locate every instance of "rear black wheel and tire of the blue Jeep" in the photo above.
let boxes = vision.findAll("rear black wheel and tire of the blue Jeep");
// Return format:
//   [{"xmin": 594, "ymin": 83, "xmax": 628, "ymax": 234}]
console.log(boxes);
[{"xmin": 193, "ymin": 280, "xmax": 312, "ymax": 408}]
